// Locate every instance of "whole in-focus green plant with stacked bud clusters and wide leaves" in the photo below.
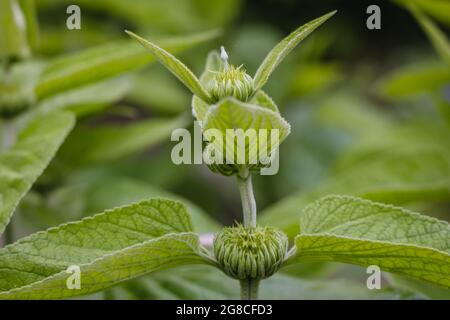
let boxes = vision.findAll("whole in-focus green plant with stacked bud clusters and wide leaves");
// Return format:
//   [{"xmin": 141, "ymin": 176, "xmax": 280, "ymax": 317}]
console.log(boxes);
[{"xmin": 0, "ymin": 12, "xmax": 450, "ymax": 299}]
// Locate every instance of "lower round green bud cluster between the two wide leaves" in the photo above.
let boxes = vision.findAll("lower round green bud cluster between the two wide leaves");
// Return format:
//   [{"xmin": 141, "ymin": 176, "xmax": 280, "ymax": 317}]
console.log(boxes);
[{"xmin": 214, "ymin": 225, "xmax": 288, "ymax": 280}]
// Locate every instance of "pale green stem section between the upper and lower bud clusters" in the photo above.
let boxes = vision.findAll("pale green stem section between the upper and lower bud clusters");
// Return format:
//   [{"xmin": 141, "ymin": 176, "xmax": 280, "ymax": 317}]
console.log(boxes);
[{"xmin": 237, "ymin": 168, "xmax": 256, "ymax": 228}]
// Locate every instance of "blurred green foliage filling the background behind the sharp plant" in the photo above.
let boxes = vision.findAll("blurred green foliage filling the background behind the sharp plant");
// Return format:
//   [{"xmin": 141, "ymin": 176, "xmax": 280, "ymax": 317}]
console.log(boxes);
[{"xmin": 0, "ymin": 0, "xmax": 450, "ymax": 299}]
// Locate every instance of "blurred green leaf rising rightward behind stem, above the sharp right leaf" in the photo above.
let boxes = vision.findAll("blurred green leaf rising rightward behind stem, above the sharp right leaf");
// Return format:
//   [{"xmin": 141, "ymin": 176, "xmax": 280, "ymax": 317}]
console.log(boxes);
[{"xmin": 259, "ymin": 148, "xmax": 450, "ymax": 236}]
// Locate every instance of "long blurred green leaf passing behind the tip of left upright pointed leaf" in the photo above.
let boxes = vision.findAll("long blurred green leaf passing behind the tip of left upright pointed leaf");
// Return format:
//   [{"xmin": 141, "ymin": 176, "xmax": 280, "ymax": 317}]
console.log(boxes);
[{"xmin": 35, "ymin": 32, "xmax": 216, "ymax": 99}]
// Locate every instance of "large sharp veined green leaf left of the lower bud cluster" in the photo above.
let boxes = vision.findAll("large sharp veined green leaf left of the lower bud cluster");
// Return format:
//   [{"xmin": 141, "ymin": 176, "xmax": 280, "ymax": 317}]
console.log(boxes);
[{"xmin": 0, "ymin": 199, "xmax": 211, "ymax": 299}]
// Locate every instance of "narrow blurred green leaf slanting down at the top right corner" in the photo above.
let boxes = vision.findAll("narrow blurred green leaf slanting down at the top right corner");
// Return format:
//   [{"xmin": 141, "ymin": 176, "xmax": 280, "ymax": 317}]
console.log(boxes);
[{"xmin": 408, "ymin": 3, "xmax": 450, "ymax": 64}]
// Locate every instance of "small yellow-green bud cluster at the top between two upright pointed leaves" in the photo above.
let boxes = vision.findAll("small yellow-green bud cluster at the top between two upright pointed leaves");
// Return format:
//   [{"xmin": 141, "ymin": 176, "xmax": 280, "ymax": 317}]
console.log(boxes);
[{"xmin": 209, "ymin": 66, "xmax": 253, "ymax": 102}]
